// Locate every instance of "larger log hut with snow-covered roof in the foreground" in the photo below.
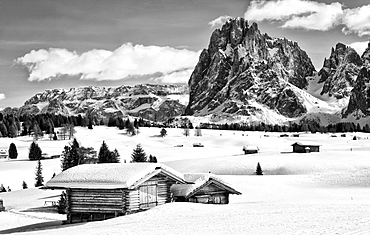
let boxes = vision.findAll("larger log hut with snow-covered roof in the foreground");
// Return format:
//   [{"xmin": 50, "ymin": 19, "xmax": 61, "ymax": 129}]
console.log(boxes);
[{"xmin": 44, "ymin": 163, "xmax": 185, "ymax": 223}]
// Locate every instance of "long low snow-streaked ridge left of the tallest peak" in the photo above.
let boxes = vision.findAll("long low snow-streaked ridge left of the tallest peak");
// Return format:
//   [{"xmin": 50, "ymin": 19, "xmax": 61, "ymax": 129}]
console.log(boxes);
[{"xmin": 17, "ymin": 84, "xmax": 188, "ymax": 121}]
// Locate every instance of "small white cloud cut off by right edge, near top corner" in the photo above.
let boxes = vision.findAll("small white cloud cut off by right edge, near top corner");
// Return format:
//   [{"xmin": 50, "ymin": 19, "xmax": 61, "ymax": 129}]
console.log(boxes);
[{"xmin": 343, "ymin": 5, "xmax": 370, "ymax": 36}]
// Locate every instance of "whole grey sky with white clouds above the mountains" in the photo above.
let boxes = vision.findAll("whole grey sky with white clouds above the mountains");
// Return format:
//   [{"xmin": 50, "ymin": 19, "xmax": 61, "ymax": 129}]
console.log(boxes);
[{"xmin": 0, "ymin": 0, "xmax": 370, "ymax": 108}]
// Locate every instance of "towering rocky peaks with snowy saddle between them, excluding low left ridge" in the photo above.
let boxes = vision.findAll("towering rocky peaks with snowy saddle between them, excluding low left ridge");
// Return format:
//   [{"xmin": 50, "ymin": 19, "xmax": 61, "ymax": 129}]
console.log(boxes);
[{"xmin": 186, "ymin": 18, "xmax": 370, "ymax": 125}]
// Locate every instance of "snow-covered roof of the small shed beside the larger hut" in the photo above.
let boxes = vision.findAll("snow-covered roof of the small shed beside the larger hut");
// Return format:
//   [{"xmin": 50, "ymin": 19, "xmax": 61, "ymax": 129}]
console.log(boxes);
[{"xmin": 171, "ymin": 173, "xmax": 241, "ymax": 198}]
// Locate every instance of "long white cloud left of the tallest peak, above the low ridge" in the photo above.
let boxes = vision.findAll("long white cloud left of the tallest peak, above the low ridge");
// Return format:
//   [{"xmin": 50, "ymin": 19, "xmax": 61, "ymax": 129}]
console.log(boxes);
[{"xmin": 16, "ymin": 43, "xmax": 200, "ymax": 81}]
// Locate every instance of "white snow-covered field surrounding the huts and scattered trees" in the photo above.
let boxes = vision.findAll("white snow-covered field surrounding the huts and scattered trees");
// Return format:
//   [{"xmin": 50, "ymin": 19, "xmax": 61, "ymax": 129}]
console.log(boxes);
[{"xmin": 0, "ymin": 127, "xmax": 370, "ymax": 234}]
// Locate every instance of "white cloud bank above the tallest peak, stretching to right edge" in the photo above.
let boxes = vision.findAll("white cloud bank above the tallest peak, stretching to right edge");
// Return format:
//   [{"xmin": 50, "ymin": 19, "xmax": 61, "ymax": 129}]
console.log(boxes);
[{"xmin": 245, "ymin": 0, "xmax": 370, "ymax": 36}]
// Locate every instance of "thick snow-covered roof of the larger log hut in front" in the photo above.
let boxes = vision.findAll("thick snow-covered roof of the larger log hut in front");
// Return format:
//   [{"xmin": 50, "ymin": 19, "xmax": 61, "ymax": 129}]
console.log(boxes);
[{"xmin": 44, "ymin": 163, "xmax": 185, "ymax": 189}]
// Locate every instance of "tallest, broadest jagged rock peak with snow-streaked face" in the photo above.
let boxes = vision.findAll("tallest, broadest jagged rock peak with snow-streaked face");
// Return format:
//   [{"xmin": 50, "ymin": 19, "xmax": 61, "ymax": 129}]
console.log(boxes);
[{"xmin": 186, "ymin": 18, "xmax": 315, "ymax": 117}]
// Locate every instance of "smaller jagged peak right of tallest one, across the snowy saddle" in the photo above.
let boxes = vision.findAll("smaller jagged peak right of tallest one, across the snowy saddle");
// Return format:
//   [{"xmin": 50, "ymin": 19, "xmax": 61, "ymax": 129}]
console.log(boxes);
[{"xmin": 318, "ymin": 43, "xmax": 363, "ymax": 99}]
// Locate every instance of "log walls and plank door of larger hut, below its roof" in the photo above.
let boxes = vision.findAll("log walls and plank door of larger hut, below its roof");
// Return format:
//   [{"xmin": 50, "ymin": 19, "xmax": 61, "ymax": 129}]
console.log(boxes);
[{"xmin": 66, "ymin": 174, "xmax": 181, "ymax": 223}]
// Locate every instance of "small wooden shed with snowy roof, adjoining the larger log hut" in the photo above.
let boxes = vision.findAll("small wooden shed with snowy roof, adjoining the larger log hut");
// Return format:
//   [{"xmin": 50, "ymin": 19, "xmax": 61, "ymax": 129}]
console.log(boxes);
[{"xmin": 171, "ymin": 173, "xmax": 241, "ymax": 204}]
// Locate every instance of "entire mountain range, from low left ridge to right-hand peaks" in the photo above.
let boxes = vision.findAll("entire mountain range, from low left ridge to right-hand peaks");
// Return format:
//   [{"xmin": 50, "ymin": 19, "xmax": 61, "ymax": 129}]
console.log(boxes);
[{"xmin": 3, "ymin": 18, "xmax": 370, "ymax": 125}]
